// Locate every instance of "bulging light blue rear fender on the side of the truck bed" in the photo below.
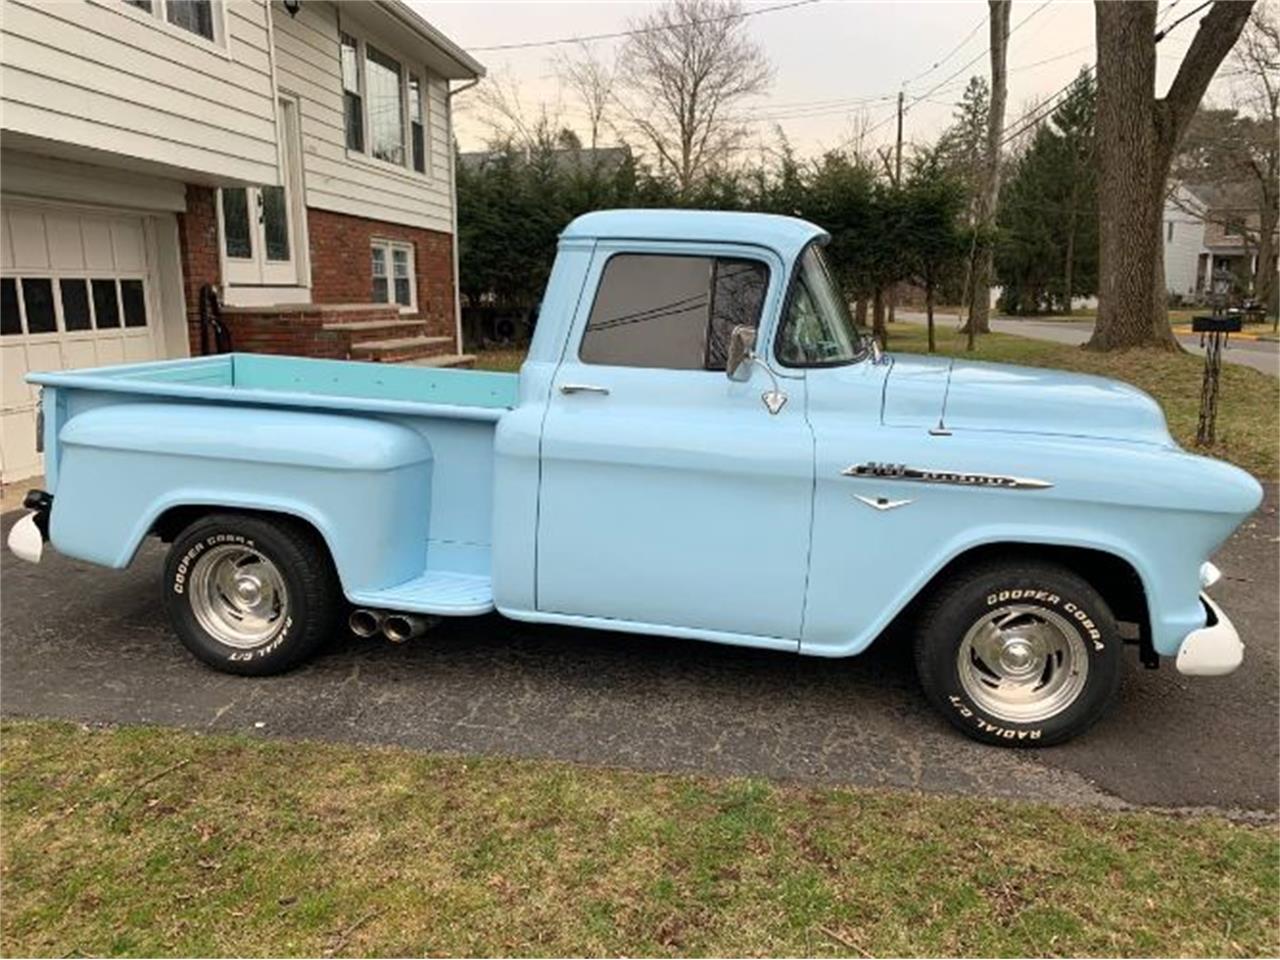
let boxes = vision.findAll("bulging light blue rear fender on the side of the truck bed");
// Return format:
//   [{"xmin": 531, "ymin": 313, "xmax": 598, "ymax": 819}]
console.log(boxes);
[{"xmin": 50, "ymin": 403, "xmax": 431, "ymax": 594}]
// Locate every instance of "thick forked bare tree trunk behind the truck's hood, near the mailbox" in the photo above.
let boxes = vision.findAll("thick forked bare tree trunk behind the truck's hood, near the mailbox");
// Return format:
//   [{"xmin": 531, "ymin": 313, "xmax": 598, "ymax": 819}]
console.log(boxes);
[{"xmin": 1087, "ymin": 0, "xmax": 1253, "ymax": 349}]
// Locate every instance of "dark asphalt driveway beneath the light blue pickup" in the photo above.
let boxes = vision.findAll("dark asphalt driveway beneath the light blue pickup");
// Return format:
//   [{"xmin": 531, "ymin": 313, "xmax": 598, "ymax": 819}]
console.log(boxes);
[{"xmin": 0, "ymin": 488, "xmax": 1280, "ymax": 814}]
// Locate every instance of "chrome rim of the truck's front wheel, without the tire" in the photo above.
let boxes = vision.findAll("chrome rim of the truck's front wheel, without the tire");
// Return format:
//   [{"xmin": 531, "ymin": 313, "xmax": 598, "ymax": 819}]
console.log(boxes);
[{"xmin": 956, "ymin": 604, "xmax": 1089, "ymax": 723}]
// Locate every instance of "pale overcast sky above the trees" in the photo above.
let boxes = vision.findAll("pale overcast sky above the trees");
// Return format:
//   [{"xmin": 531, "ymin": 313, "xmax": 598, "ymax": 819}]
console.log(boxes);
[{"xmin": 415, "ymin": 0, "xmax": 1218, "ymax": 155}]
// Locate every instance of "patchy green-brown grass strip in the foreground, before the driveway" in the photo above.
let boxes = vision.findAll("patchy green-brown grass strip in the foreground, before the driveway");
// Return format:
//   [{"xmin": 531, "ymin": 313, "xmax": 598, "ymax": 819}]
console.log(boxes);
[{"xmin": 0, "ymin": 722, "xmax": 1280, "ymax": 956}]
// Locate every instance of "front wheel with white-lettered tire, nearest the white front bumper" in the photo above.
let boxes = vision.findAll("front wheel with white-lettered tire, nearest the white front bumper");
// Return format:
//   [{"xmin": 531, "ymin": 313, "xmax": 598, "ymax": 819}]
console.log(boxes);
[{"xmin": 915, "ymin": 562, "xmax": 1121, "ymax": 746}]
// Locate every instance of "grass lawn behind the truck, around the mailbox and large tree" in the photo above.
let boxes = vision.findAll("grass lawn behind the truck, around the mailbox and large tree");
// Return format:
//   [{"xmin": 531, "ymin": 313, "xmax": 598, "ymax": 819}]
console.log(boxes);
[{"xmin": 477, "ymin": 320, "xmax": 1280, "ymax": 480}]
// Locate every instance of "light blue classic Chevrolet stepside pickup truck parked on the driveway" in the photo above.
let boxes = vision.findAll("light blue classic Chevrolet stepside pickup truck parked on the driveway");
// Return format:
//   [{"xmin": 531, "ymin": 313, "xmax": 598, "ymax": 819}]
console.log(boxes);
[{"xmin": 10, "ymin": 211, "xmax": 1261, "ymax": 746}]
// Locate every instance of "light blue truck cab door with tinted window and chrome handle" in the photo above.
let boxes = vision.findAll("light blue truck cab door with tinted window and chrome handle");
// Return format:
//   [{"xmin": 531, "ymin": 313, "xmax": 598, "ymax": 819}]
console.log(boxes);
[{"xmin": 538, "ymin": 242, "xmax": 813, "ymax": 649}]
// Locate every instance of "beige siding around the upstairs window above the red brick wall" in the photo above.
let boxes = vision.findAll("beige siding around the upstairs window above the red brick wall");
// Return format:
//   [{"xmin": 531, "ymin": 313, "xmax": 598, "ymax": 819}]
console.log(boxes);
[{"xmin": 273, "ymin": 1, "xmax": 452, "ymax": 232}]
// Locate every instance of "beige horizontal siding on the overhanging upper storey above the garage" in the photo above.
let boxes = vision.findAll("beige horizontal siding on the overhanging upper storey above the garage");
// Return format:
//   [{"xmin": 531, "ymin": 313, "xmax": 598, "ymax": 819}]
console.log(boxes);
[{"xmin": 0, "ymin": 0, "xmax": 279, "ymax": 183}]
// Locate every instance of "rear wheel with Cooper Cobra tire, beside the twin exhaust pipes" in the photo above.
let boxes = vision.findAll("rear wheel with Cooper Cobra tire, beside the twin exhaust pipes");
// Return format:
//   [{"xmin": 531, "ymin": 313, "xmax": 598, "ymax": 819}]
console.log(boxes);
[{"xmin": 165, "ymin": 513, "xmax": 339, "ymax": 676}]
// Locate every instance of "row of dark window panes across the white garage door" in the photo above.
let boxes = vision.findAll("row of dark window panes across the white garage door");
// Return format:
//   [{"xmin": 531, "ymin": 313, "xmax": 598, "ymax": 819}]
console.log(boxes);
[{"xmin": 0, "ymin": 276, "xmax": 147, "ymax": 337}]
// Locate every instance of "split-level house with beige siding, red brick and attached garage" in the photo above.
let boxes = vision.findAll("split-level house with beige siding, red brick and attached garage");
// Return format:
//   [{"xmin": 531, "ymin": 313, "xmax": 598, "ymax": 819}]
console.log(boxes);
[{"xmin": 0, "ymin": 0, "xmax": 484, "ymax": 481}]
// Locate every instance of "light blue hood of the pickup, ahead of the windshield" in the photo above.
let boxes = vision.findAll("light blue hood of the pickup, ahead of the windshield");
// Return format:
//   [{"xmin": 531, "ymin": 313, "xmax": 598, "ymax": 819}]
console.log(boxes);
[{"xmin": 883, "ymin": 353, "xmax": 1174, "ymax": 445}]
